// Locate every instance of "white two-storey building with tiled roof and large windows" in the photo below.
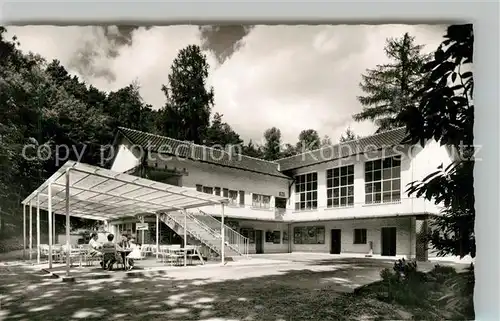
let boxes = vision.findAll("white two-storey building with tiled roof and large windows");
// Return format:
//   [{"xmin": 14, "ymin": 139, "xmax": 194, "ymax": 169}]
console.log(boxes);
[{"xmin": 109, "ymin": 128, "xmax": 451, "ymax": 260}]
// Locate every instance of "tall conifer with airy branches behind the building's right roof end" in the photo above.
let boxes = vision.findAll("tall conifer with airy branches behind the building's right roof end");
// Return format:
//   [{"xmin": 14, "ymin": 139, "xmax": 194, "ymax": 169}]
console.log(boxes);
[{"xmin": 353, "ymin": 33, "xmax": 429, "ymax": 132}]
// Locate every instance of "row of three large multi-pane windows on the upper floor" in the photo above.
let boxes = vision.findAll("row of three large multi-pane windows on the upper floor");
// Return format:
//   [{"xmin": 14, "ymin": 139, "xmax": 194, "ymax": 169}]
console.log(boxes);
[{"xmin": 295, "ymin": 157, "xmax": 401, "ymax": 210}]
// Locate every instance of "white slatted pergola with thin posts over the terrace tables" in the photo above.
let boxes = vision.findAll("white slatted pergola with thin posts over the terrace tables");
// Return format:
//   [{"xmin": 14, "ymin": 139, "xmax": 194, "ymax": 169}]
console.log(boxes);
[{"xmin": 21, "ymin": 161, "xmax": 228, "ymax": 276}]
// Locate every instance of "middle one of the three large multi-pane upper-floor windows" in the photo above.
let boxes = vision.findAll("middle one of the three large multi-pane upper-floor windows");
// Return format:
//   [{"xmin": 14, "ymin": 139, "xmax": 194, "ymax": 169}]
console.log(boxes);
[{"xmin": 326, "ymin": 165, "xmax": 354, "ymax": 207}]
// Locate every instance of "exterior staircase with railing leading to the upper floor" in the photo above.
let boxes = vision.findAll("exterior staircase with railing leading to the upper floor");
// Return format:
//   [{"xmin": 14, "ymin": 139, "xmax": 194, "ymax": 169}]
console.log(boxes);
[{"xmin": 160, "ymin": 211, "xmax": 249, "ymax": 258}]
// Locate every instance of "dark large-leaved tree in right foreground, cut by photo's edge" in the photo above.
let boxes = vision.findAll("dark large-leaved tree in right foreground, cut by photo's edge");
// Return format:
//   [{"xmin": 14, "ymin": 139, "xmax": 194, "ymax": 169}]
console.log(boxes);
[{"xmin": 399, "ymin": 24, "xmax": 476, "ymax": 257}]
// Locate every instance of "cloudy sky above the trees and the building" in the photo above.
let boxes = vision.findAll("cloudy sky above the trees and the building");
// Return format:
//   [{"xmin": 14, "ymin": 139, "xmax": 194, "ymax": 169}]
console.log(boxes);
[{"xmin": 8, "ymin": 25, "xmax": 445, "ymax": 143}]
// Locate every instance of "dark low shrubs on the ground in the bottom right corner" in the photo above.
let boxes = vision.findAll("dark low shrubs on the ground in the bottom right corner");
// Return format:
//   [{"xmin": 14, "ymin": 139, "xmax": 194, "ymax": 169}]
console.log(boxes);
[{"xmin": 357, "ymin": 260, "xmax": 474, "ymax": 320}]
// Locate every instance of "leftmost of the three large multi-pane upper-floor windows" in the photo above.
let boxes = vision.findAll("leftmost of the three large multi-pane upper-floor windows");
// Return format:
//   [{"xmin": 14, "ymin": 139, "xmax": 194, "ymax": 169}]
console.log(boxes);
[{"xmin": 295, "ymin": 173, "xmax": 318, "ymax": 210}]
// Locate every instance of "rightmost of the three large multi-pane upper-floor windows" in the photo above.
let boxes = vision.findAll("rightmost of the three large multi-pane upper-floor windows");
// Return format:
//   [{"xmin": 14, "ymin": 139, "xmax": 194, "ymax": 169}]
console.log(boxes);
[{"xmin": 365, "ymin": 157, "xmax": 401, "ymax": 204}]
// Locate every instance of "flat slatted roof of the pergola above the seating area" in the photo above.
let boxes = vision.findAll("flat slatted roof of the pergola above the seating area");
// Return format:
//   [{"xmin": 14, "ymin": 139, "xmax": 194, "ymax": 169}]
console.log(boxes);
[{"xmin": 21, "ymin": 161, "xmax": 228, "ymax": 220}]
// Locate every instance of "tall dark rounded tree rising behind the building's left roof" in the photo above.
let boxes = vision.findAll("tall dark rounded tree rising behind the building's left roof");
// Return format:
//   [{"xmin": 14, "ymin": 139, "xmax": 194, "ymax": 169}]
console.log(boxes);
[{"xmin": 157, "ymin": 45, "xmax": 214, "ymax": 143}]
